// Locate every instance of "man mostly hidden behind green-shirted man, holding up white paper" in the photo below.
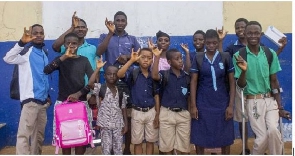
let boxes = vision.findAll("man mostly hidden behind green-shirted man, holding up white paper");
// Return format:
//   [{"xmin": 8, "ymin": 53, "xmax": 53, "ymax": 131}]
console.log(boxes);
[{"xmin": 224, "ymin": 18, "xmax": 287, "ymax": 155}]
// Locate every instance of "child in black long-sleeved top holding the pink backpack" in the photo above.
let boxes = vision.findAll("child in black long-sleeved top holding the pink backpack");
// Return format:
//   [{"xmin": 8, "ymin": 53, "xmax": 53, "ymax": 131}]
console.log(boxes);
[{"xmin": 44, "ymin": 33, "xmax": 93, "ymax": 155}]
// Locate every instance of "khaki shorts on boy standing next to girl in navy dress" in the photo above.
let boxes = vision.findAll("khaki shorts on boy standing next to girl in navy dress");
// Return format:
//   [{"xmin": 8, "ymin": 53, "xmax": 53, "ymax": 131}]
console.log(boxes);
[{"xmin": 159, "ymin": 107, "xmax": 191, "ymax": 153}]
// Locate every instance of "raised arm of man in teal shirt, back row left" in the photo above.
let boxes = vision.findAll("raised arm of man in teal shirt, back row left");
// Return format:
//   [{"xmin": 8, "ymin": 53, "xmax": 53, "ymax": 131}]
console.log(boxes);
[{"xmin": 52, "ymin": 11, "xmax": 79, "ymax": 52}]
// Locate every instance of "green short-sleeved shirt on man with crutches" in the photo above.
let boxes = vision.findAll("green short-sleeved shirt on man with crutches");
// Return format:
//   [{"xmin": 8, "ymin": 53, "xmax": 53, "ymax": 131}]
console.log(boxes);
[{"xmin": 233, "ymin": 46, "xmax": 282, "ymax": 95}]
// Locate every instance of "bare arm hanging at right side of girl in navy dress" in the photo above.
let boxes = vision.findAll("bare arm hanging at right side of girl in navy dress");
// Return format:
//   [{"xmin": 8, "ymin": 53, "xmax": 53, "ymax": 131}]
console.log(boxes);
[{"xmin": 225, "ymin": 72, "xmax": 236, "ymax": 120}]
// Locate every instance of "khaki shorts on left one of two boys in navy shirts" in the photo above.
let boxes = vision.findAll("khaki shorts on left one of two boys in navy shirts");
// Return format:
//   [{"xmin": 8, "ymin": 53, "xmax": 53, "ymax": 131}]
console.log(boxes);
[{"xmin": 131, "ymin": 107, "xmax": 159, "ymax": 144}]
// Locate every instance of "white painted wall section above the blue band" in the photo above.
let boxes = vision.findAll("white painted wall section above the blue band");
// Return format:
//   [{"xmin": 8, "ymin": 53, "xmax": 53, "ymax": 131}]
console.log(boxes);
[{"xmin": 42, "ymin": 1, "xmax": 223, "ymax": 39}]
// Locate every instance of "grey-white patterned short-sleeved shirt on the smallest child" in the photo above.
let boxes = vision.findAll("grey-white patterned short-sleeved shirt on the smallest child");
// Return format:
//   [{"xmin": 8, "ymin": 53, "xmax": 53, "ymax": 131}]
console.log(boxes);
[{"xmin": 93, "ymin": 83, "xmax": 127, "ymax": 128}]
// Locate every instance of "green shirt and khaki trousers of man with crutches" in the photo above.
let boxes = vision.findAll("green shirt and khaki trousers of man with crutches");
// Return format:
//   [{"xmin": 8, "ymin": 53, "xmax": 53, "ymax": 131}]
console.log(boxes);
[{"xmin": 233, "ymin": 47, "xmax": 283, "ymax": 155}]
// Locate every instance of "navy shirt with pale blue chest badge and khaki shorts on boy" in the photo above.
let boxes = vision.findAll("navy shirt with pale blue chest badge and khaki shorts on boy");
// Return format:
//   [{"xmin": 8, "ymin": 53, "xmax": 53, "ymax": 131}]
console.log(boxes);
[{"xmin": 159, "ymin": 68, "xmax": 191, "ymax": 152}]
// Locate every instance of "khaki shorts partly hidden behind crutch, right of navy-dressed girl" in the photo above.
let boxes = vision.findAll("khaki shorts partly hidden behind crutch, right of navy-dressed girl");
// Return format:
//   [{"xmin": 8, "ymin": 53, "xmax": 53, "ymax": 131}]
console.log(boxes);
[{"xmin": 234, "ymin": 86, "xmax": 248, "ymax": 122}]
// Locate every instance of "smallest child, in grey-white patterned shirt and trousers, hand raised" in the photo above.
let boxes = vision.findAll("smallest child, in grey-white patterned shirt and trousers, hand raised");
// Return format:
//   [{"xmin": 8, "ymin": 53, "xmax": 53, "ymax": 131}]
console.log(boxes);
[{"xmin": 88, "ymin": 60, "xmax": 128, "ymax": 155}]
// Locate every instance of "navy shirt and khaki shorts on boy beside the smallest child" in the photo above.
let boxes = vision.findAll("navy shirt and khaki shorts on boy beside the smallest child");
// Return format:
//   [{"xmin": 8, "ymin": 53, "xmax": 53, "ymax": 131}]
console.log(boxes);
[{"xmin": 124, "ymin": 68, "xmax": 159, "ymax": 144}]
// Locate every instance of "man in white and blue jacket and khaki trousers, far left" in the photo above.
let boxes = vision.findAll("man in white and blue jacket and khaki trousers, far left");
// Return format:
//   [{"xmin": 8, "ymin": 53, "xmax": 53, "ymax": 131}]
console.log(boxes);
[{"xmin": 3, "ymin": 24, "xmax": 51, "ymax": 155}]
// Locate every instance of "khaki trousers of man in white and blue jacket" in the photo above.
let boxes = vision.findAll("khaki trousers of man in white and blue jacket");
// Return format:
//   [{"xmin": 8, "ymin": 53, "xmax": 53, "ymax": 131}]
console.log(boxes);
[{"xmin": 16, "ymin": 102, "xmax": 50, "ymax": 155}]
